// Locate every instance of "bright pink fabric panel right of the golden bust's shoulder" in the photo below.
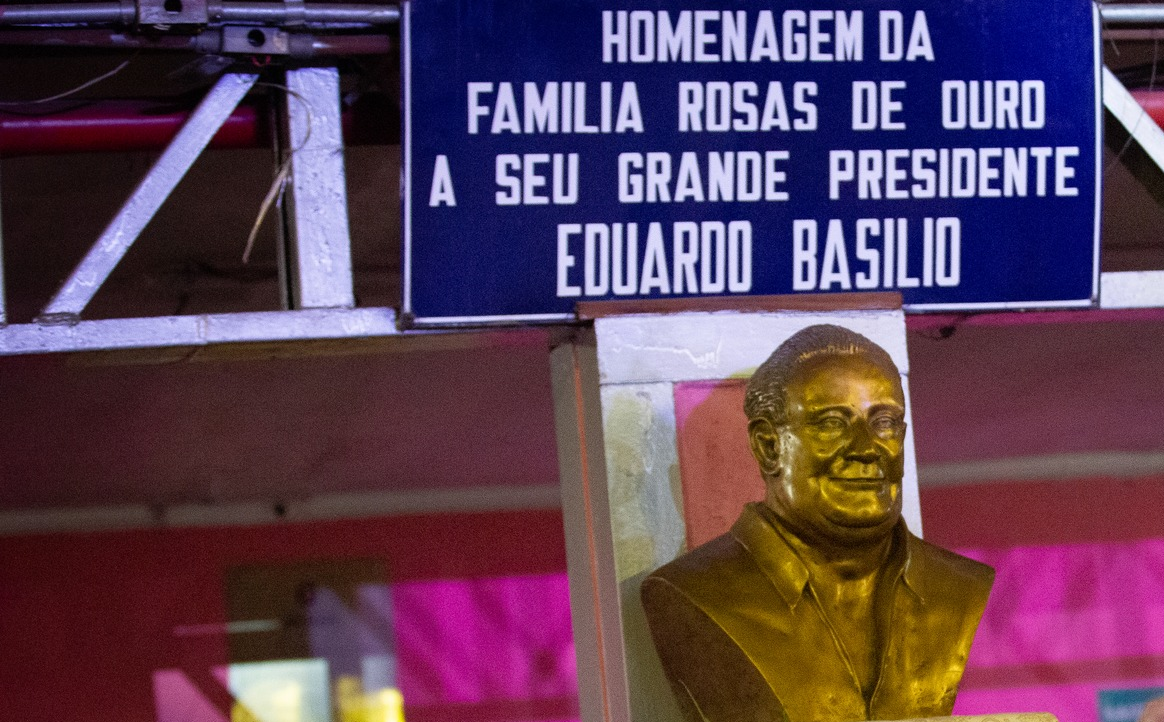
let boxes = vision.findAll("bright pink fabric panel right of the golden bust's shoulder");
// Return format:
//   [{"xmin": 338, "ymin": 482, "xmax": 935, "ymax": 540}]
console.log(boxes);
[{"xmin": 956, "ymin": 539, "xmax": 1164, "ymax": 722}]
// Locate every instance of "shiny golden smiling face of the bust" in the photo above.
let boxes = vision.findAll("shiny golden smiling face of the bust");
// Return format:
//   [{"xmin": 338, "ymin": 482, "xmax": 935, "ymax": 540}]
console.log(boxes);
[{"xmin": 767, "ymin": 355, "xmax": 906, "ymax": 545}]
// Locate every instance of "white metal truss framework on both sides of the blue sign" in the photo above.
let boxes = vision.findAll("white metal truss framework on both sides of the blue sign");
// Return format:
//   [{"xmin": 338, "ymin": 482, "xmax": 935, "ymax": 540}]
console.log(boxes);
[{"xmin": 0, "ymin": 0, "xmax": 1164, "ymax": 355}]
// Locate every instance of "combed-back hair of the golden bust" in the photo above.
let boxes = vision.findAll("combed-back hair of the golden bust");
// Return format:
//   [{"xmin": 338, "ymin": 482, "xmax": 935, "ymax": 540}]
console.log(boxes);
[{"xmin": 744, "ymin": 324, "xmax": 900, "ymax": 426}]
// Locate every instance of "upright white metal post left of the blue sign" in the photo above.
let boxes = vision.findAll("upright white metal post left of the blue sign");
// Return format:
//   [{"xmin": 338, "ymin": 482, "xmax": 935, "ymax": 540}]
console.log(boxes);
[{"xmin": 286, "ymin": 68, "xmax": 355, "ymax": 309}]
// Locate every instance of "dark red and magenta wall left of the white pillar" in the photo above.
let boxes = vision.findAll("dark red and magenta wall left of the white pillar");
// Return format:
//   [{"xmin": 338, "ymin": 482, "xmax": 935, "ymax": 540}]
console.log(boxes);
[{"xmin": 0, "ymin": 511, "xmax": 577, "ymax": 722}]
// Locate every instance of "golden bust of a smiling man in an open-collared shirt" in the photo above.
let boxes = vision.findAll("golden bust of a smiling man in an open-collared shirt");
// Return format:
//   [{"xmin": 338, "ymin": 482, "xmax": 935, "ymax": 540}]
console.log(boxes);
[{"xmin": 643, "ymin": 326, "xmax": 994, "ymax": 722}]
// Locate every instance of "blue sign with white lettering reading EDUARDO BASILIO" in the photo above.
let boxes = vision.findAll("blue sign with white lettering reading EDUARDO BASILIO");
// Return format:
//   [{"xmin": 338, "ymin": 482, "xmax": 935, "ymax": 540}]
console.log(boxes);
[{"xmin": 402, "ymin": 0, "xmax": 1101, "ymax": 324}]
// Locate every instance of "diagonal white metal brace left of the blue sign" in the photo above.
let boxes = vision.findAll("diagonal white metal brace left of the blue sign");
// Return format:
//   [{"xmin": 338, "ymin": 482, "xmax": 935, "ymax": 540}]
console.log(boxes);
[{"xmin": 37, "ymin": 73, "xmax": 258, "ymax": 324}]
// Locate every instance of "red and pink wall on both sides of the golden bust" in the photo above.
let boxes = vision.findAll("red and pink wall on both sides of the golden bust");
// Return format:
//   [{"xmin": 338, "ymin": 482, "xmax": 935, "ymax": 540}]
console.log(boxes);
[{"xmin": 0, "ymin": 477, "xmax": 1164, "ymax": 722}]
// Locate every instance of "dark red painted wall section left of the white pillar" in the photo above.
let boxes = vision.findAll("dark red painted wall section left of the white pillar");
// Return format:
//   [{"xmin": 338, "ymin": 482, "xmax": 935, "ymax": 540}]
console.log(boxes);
[{"xmin": 0, "ymin": 511, "xmax": 569, "ymax": 722}]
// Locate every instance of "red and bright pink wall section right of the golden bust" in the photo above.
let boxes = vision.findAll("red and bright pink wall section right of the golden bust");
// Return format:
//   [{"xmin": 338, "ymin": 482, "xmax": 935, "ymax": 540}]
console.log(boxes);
[{"xmin": 922, "ymin": 477, "xmax": 1164, "ymax": 722}]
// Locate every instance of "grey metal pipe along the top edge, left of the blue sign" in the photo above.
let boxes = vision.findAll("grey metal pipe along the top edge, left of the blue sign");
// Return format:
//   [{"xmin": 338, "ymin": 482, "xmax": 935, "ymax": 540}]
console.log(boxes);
[{"xmin": 0, "ymin": 0, "xmax": 400, "ymax": 27}]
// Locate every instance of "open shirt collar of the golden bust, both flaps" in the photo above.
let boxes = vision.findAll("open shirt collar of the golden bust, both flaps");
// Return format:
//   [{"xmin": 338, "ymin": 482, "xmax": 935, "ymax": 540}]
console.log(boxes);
[{"xmin": 731, "ymin": 502, "xmax": 925, "ymax": 608}]
